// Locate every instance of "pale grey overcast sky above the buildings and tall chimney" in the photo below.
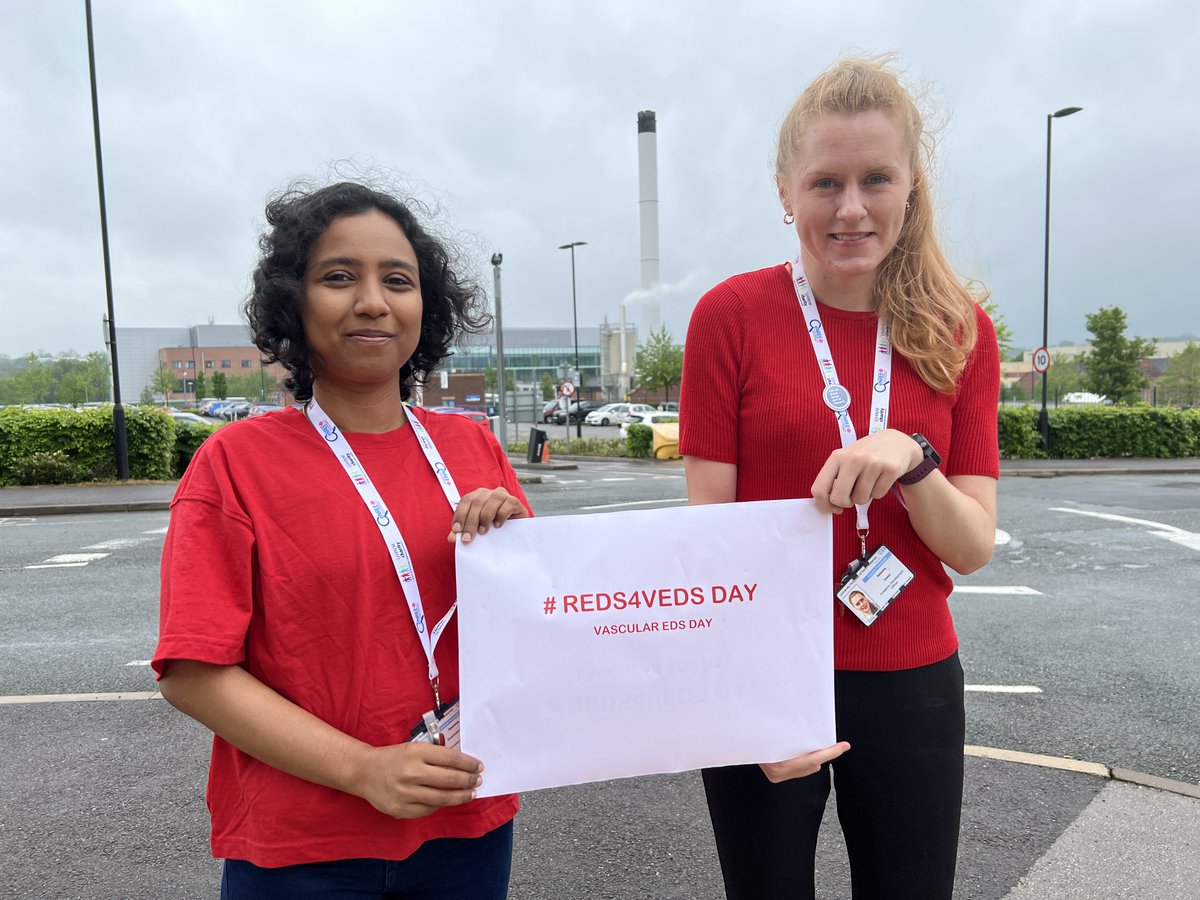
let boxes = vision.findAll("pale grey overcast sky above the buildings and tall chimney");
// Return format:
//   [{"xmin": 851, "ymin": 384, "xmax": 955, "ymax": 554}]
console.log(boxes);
[{"xmin": 0, "ymin": 0, "xmax": 1200, "ymax": 355}]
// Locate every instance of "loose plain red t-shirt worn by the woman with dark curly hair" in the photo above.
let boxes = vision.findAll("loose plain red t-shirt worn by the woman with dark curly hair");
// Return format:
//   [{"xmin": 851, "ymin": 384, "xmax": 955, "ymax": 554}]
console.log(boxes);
[{"xmin": 151, "ymin": 409, "xmax": 528, "ymax": 866}]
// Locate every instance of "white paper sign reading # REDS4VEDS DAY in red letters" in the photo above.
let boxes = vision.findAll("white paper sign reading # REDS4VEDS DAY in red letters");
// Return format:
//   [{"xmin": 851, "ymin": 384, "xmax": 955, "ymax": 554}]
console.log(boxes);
[{"xmin": 457, "ymin": 500, "xmax": 835, "ymax": 797}]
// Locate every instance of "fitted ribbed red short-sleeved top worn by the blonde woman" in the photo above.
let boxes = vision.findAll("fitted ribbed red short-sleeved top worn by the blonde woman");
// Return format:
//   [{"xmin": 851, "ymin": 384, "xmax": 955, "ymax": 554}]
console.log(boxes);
[{"xmin": 679, "ymin": 265, "xmax": 1000, "ymax": 671}]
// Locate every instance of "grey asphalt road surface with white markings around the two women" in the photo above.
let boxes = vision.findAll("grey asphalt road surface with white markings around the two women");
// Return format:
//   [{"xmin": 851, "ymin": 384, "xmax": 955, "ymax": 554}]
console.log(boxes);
[{"xmin": 0, "ymin": 462, "xmax": 1200, "ymax": 900}]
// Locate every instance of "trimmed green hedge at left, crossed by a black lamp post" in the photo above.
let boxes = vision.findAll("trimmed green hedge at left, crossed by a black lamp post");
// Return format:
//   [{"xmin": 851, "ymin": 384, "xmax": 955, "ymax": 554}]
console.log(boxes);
[{"xmin": 0, "ymin": 407, "xmax": 214, "ymax": 485}]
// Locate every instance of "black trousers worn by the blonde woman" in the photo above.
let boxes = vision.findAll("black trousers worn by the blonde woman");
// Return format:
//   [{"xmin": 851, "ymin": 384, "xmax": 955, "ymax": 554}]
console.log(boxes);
[{"xmin": 703, "ymin": 653, "xmax": 966, "ymax": 900}]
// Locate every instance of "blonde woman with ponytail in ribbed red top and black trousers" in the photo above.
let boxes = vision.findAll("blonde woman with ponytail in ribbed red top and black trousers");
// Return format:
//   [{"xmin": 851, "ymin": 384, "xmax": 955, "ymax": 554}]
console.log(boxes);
[{"xmin": 679, "ymin": 59, "xmax": 1000, "ymax": 900}]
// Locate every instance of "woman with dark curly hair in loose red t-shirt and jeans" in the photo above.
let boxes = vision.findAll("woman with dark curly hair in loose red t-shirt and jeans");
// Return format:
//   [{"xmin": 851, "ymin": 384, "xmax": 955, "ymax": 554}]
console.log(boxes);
[{"xmin": 152, "ymin": 184, "xmax": 529, "ymax": 900}]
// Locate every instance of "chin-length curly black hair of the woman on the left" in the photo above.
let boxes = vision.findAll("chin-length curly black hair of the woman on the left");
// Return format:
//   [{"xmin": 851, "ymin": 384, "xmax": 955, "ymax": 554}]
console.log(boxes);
[{"xmin": 242, "ymin": 181, "xmax": 492, "ymax": 402}]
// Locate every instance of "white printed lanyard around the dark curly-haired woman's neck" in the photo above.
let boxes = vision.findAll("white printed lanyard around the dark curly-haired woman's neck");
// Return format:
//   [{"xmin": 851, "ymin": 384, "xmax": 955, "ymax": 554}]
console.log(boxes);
[{"xmin": 305, "ymin": 397, "xmax": 462, "ymax": 708}]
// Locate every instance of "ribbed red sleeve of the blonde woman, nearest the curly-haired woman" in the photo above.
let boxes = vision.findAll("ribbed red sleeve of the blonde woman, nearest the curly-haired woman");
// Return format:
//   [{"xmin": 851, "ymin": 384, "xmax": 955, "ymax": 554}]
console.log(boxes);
[{"xmin": 679, "ymin": 284, "xmax": 745, "ymax": 464}]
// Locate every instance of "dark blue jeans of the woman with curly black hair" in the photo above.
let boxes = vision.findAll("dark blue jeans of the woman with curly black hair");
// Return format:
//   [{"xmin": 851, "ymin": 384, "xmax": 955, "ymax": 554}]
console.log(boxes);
[{"xmin": 221, "ymin": 822, "xmax": 512, "ymax": 900}]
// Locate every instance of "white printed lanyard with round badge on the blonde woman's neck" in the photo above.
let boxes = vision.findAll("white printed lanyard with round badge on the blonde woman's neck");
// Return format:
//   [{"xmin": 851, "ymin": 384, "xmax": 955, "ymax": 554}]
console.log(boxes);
[{"xmin": 792, "ymin": 253, "xmax": 892, "ymax": 542}]
